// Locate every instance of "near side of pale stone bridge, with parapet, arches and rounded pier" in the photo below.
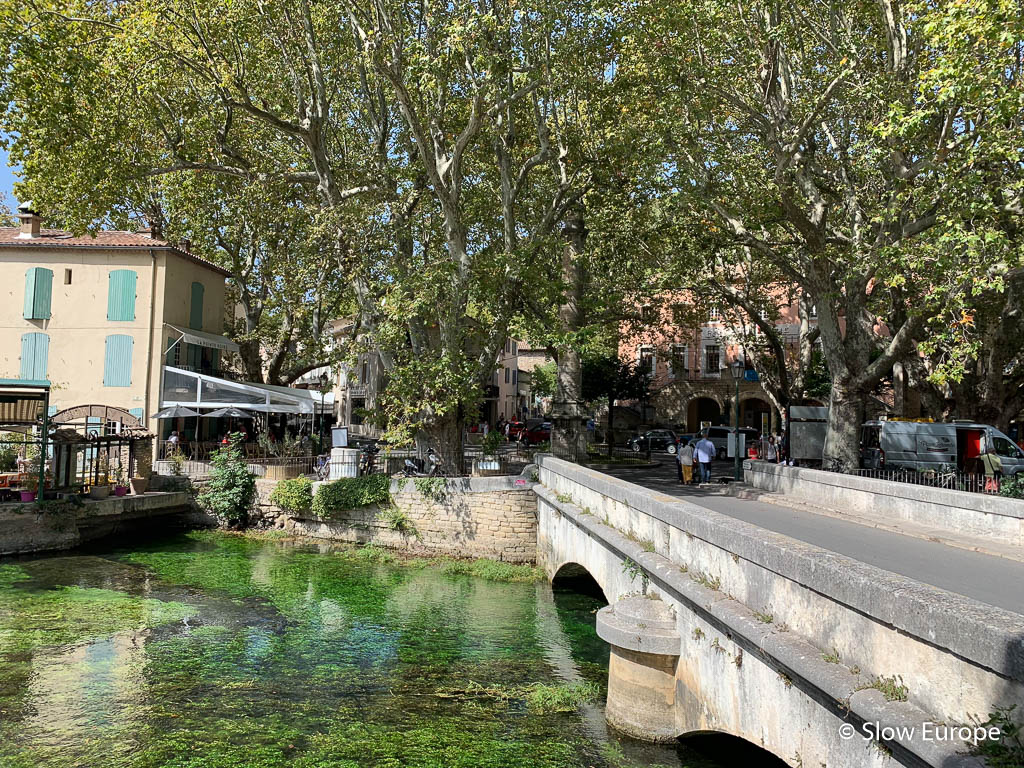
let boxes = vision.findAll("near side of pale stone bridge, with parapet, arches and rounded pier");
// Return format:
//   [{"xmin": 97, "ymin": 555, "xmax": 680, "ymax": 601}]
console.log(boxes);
[{"xmin": 536, "ymin": 457, "xmax": 1024, "ymax": 768}]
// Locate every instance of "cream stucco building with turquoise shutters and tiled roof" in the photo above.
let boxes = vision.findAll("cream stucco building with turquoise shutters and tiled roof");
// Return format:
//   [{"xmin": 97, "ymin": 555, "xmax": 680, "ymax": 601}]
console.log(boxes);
[{"xmin": 0, "ymin": 207, "xmax": 237, "ymax": 442}]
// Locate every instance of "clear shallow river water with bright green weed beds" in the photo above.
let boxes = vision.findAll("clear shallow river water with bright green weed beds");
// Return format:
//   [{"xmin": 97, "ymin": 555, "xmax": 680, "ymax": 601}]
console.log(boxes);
[{"xmin": 0, "ymin": 532, "xmax": 749, "ymax": 768}]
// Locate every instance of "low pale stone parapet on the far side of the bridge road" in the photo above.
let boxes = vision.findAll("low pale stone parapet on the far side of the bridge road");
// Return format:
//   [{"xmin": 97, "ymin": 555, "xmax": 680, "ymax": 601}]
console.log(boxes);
[{"xmin": 743, "ymin": 461, "xmax": 1024, "ymax": 547}]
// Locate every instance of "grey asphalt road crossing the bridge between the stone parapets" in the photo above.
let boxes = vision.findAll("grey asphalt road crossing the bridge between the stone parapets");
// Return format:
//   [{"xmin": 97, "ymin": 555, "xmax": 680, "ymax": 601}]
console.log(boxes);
[{"xmin": 604, "ymin": 462, "xmax": 1024, "ymax": 614}]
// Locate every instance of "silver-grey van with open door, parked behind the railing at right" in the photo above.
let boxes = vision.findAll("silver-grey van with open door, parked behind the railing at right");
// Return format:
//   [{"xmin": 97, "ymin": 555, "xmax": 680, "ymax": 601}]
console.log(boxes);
[{"xmin": 860, "ymin": 421, "xmax": 1024, "ymax": 476}]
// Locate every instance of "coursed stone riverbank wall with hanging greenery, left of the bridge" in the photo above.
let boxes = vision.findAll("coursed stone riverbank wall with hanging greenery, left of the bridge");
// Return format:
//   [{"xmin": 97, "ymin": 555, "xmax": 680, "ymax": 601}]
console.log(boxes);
[{"xmin": 280, "ymin": 475, "xmax": 537, "ymax": 563}]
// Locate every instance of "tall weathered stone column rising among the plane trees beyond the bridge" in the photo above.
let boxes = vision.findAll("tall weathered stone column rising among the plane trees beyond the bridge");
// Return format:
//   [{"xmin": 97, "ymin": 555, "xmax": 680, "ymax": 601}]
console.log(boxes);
[{"xmin": 551, "ymin": 211, "xmax": 587, "ymax": 458}]
